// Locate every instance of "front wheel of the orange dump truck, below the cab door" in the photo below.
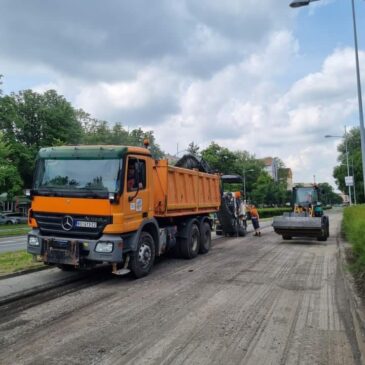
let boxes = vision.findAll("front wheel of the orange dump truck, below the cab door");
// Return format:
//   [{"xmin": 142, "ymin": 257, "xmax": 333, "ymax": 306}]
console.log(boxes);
[{"xmin": 129, "ymin": 232, "xmax": 156, "ymax": 279}]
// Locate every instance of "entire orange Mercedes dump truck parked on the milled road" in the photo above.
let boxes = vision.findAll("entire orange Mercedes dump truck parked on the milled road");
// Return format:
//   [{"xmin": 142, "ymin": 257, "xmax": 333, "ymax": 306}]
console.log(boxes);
[{"xmin": 27, "ymin": 146, "xmax": 220, "ymax": 277}]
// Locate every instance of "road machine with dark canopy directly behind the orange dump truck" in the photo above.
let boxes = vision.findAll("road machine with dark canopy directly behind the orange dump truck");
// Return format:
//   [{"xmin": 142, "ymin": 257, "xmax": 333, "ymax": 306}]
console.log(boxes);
[{"xmin": 216, "ymin": 175, "xmax": 247, "ymax": 237}]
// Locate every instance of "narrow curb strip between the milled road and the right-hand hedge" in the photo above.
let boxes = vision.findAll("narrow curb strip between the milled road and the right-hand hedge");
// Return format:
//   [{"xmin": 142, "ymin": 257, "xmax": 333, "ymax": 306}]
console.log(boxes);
[{"xmin": 336, "ymin": 233, "xmax": 365, "ymax": 363}]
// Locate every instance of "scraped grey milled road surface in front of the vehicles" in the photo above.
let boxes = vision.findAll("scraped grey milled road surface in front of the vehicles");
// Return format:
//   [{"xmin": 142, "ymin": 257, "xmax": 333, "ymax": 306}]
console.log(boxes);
[{"xmin": 0, "ymin": 212, "xmax": 361, "ymax": 365}]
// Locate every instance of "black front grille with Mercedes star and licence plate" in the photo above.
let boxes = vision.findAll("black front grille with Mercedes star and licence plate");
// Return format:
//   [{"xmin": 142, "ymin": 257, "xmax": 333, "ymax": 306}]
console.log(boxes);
[{"xmin": 33, "ymin": 212, "xmax": 112, "ymax": 239}]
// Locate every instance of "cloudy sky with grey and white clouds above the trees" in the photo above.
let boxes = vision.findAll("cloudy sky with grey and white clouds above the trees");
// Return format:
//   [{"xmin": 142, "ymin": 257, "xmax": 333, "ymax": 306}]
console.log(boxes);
[{"xmin": 0, "ymin": 0, "xmax": 365, "ymax": 188}]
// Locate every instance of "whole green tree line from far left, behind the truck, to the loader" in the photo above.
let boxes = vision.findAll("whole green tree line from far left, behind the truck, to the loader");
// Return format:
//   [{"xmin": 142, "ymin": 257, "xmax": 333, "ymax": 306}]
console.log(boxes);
[{"xmin": 0, "ymin": 76, "xmax": 342, "ymax": 205}]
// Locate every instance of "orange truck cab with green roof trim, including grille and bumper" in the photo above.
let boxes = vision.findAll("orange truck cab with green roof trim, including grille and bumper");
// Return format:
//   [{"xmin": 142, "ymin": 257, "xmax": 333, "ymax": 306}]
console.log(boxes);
[{"xmin": 28, "ymin": 146, "xmax": 158, "ymax": 268}]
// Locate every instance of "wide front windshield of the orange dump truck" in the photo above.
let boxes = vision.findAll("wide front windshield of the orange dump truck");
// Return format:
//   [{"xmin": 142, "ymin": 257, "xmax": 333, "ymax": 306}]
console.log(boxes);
[{"xmin": 34, "ymin": 159, "xmax": 122, "ymax": 195}]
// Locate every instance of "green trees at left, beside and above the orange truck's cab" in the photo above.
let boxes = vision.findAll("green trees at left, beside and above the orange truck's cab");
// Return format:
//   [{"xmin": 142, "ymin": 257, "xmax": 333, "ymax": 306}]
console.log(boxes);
[{"xmin": 0, "ymin": 83, "xmax": 164, "ymax": 197}]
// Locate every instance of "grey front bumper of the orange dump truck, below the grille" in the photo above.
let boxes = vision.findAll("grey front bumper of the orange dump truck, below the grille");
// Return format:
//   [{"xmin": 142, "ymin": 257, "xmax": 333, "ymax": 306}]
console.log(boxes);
[{"xmin": 27, "ymin": 229, "xmax": 123, "ymax": 266}]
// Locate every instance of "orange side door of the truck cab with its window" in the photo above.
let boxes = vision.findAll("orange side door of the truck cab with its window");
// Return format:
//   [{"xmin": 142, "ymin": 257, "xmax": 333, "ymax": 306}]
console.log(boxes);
[{"xmin": 123, "ymin": 155, "xmax": 150, "ymax": 232}]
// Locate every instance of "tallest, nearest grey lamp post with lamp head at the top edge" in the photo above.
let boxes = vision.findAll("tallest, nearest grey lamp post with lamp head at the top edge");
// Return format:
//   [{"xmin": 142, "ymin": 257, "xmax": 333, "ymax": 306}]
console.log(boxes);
[{"xmin": 289, "ymin": 0, "xmax": 365, "ymax": 200}]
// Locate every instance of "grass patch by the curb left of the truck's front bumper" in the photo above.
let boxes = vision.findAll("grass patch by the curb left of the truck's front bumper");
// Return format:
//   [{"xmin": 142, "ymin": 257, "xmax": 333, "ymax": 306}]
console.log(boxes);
[{"xmin": 0, "ymin": 250, "xmax": 44, "ymax": 276}]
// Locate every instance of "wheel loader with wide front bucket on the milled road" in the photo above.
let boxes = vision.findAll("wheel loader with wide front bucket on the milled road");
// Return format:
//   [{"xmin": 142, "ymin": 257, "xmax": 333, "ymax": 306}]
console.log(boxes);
[{"xmin": 272, "ymin": 185, "xmax": 329, "ymax": 241}]
